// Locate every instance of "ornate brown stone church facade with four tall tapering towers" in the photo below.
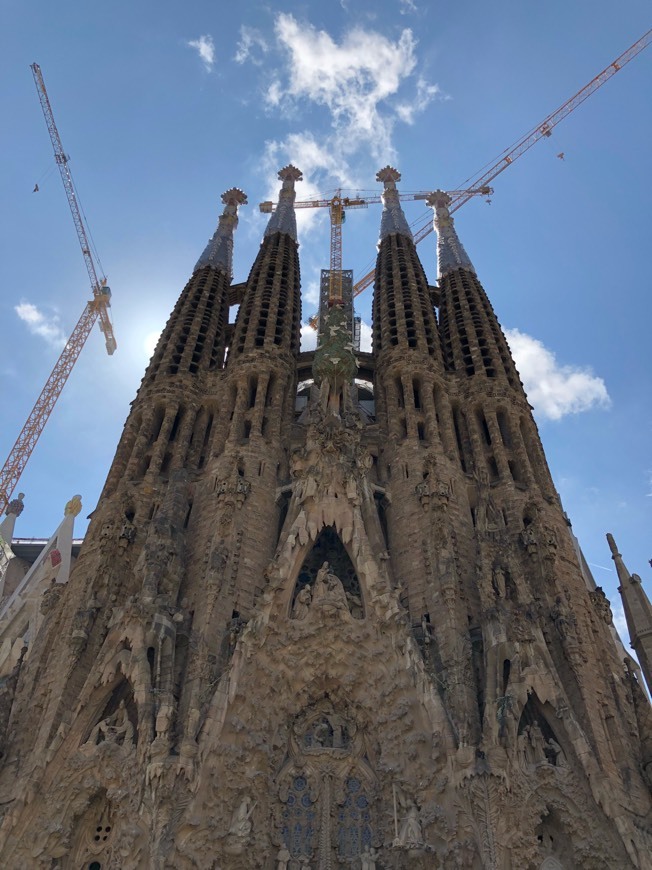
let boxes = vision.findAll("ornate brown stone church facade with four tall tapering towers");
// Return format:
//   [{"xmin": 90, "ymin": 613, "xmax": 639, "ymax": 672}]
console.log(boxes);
[{"xmin": 0, "ymin": 166, "xmax": 652, "ymax": 870}]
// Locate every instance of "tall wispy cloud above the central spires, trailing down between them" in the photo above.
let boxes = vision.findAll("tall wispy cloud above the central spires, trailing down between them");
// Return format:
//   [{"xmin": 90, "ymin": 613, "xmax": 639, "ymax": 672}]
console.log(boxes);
[{"xmin": 250, "ymin": 13, "xmax": 440, "ymax": 217}]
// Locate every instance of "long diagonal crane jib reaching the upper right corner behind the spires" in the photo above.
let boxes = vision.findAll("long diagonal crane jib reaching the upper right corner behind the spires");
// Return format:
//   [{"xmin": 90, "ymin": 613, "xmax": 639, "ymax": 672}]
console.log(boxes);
[{"xmin": 348, "ymin": 30, "xmax": 652, "ymax": 304}]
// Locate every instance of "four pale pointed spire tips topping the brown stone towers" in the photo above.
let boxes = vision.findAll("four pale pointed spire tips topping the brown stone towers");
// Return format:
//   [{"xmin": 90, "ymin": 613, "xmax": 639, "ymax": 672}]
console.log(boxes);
[{"xmin": 194, "ymin": 163, "xmax": 476, "ymax": 278}]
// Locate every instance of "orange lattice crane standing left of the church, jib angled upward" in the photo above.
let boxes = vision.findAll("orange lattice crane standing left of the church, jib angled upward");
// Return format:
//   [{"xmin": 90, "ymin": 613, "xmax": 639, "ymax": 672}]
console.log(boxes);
[{"xmin": 0, "ymin": 63, "xmax": 117, "ymax": 511}]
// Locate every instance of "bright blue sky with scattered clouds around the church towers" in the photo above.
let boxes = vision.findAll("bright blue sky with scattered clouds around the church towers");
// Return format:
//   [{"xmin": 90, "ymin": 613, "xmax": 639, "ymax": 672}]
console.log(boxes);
[{"xmin": 0, "ymin": 0, "xmax": 652, "ymax": 640}]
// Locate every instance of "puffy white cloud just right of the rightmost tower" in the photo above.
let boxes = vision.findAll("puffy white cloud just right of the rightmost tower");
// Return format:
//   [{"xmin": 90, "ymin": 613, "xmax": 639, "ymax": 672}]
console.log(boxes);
[{"xmin": 505, "ymin": 329, "xmax": 611, "ymax": 420}]
